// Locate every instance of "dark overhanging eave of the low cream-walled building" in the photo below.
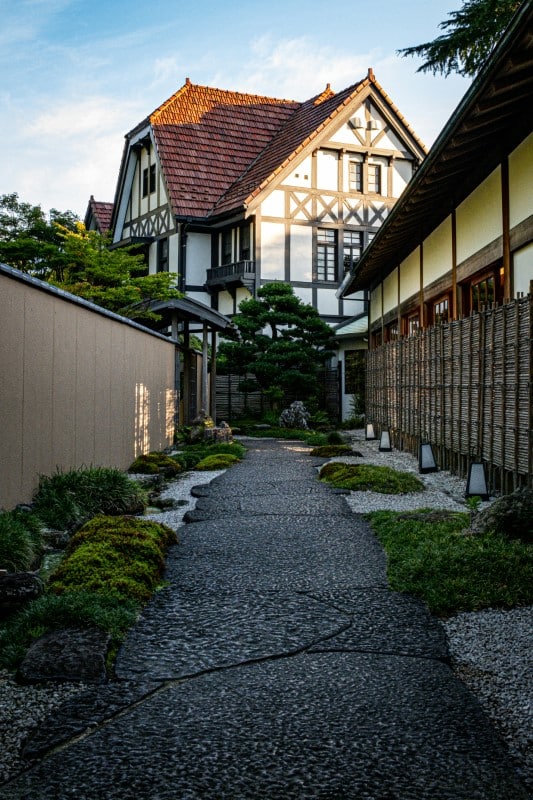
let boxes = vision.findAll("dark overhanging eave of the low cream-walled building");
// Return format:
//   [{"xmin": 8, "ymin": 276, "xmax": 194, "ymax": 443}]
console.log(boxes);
[{"xmin": 337, "ymin": 2, "xmax": 533, "ymax": 297}]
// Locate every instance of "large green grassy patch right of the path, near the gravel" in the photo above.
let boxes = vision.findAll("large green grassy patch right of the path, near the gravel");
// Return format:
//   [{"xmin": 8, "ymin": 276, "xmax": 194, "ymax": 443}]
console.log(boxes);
[{"xmin": 368, "ymin": 511, "xmax": 533, "ymax": 616}]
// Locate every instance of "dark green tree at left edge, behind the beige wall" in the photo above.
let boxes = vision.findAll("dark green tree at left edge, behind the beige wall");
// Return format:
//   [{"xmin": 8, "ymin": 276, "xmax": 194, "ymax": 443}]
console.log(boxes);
[{"xmin": 0, "ymin": 192, "xmax": 78, "ymax": 280}]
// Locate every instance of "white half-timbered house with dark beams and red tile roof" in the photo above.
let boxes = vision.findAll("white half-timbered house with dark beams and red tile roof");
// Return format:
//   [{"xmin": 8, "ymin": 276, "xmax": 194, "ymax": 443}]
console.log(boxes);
[{"xmin": 98, "ymin": 70, "xmax": 426, "ymax": 416}]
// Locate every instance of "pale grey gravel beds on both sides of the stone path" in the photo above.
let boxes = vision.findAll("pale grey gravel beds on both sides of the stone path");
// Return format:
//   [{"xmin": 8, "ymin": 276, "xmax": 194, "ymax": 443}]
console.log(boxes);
[{"xmin": 0, "ymin": 446, "xmax": 533, "ymax": 792}]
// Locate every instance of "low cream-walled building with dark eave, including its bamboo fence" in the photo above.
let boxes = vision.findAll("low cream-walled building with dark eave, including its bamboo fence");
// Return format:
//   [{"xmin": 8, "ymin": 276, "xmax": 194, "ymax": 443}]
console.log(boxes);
[{"xmin": 338, "ymin": 2, "xmax": 533, "ymax": 491}]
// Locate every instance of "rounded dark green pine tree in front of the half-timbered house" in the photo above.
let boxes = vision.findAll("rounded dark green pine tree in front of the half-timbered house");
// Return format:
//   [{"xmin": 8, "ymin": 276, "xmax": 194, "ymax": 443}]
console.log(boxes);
[{"xmin": 219, "ymin": 283, "xmax": 335, "ymax": 400}]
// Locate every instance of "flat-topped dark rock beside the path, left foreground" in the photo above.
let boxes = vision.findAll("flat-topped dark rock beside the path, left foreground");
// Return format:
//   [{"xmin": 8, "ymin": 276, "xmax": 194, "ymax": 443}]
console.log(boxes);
[{"xmin": 17, "ymin": 628, "xmax": 110, "ymax": 684}]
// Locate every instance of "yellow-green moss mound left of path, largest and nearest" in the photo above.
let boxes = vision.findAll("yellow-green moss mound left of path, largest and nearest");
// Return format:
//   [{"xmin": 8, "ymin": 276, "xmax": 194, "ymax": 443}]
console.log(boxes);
[{"xmin": 49, "ymin": 516, "xmax": 176, "ymax": 602}]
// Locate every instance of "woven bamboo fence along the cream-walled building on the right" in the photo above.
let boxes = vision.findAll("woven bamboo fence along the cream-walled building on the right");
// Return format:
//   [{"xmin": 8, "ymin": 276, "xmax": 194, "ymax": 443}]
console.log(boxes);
[{"xmin": 366, "ymin": 295, "xmax": 533, "ymax": 492}]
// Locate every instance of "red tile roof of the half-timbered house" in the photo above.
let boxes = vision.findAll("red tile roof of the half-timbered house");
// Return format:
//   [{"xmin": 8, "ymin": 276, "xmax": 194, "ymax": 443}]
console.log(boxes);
[{"xmin": 132, "ymin": 70, "xmax": 425, "ymax": 218}]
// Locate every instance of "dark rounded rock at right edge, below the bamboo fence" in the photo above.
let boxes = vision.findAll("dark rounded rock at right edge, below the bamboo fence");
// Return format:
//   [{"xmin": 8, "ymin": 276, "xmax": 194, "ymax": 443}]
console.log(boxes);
[{"xmin": 472, "ymin": 488, "xmax": 533, "ymax": 543}]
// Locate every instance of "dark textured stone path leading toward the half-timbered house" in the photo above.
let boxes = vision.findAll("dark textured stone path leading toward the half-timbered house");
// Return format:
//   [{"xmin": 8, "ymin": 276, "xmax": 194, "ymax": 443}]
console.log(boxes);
[{"xmin": 0, "ymin": 440, "xmax": 527, "ymax": 800}]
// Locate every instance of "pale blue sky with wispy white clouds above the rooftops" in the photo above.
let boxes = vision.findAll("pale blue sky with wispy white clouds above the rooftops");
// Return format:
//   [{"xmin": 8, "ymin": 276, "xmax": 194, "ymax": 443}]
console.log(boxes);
[{"xmin": 0, "ymin": 0, "xmax": 470, "ymax": 219}]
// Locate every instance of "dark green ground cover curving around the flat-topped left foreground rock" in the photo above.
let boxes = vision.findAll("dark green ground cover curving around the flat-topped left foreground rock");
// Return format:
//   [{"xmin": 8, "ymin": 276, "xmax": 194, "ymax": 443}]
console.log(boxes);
[{"xmin": 0, "ymin": 591, "xmax": 139, "ymax": 669}]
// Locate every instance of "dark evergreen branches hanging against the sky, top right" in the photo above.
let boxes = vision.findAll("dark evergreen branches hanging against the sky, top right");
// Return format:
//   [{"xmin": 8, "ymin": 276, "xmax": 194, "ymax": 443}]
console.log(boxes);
[{"xmin": 398, "ymin": 0, "xmax": 522, "ymax": 77}]
